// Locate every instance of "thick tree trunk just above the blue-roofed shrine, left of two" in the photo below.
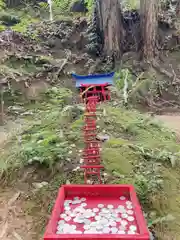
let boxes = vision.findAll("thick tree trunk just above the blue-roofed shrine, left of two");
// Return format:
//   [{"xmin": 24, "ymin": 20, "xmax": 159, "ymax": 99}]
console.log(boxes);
[{"xmin": 96, "ymin": 0, "xmax": 123, "ymax": 59}]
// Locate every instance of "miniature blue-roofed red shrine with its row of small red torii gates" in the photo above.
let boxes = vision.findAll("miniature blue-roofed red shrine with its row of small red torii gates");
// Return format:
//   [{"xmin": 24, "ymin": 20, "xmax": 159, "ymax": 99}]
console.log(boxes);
[{"xmin": 72, "ymin": 73, "xmax": 114, "ymax": 184}]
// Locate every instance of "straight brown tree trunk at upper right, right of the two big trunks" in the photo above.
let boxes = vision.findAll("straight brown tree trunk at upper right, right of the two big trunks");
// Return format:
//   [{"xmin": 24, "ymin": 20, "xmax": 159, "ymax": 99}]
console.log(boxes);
[{"xmin": 140, "ymin": 0, "xmax": 159, "ymax": 61}]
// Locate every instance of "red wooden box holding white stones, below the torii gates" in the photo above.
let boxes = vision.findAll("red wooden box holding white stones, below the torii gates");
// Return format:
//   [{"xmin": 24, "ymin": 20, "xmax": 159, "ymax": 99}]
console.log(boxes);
[{"xmin": 44, "ymin": 185, "xmax": 150, "ymax": 240}]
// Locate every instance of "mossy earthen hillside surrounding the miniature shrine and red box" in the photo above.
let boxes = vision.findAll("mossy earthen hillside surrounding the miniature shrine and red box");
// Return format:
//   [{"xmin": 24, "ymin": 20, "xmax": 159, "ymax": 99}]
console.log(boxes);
[{"xmin": 0, "ymin": 0, "xmax": 180, "ymax": 240}]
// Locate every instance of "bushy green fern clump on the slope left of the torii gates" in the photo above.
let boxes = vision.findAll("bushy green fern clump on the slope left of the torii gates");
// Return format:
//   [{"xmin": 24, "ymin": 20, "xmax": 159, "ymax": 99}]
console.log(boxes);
[{"xmin": 20, "ymin": 126, "xmax": 69, "ymax": 168}]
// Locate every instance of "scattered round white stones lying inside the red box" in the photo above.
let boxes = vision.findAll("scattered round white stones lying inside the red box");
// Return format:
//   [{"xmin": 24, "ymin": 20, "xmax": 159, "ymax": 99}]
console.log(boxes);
[{"xmin": 56, "ymin": 196, "xmax": 138, "ymax": 235}]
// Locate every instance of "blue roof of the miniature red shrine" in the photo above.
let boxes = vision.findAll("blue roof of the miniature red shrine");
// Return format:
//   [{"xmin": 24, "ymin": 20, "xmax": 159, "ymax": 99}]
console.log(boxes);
[{"xmin": 72, "ymin": 72, "xmax": 114, "ymax": 87}]
